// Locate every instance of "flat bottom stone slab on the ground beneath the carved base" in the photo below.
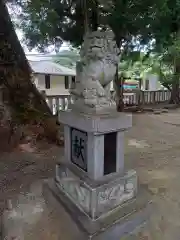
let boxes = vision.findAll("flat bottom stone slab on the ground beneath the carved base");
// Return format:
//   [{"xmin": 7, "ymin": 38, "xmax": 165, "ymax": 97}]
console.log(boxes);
[{"xmin": 43, "ymin": 180, "xmax": 152, "ymax": 240}]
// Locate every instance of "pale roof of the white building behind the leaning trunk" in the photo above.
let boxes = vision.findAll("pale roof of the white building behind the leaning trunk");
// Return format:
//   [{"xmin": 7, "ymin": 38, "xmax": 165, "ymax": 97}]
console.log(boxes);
[{"xmin": 29, "ymin": 60, "xmax": 76, "ymax": 76}]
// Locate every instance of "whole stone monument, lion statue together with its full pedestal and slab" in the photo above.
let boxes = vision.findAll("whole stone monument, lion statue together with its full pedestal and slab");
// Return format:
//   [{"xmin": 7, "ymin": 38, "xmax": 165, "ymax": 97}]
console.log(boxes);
[{"xmin": 43, "ymin": 29, "xmax": 149, "ymax": 240}]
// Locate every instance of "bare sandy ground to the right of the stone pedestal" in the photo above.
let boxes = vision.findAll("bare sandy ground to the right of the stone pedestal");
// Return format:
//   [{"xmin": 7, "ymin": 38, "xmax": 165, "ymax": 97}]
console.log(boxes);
[{"xmin": 125, "ymin": 110, "xmax": 180, "ymax": 240}]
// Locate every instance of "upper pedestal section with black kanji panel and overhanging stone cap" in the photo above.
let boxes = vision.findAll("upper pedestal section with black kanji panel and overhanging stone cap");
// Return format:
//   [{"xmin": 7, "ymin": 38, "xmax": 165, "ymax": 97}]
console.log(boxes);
[{"xmin": 59, "ymin": 111, "xmax": 132, "ymax": 177}]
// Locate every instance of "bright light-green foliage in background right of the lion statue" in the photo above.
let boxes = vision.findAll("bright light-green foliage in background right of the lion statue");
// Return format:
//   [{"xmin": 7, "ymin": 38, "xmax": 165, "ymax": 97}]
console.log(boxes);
[{"xmin": 119, "ymin": 47, "xmax": 173, "ymax": 90}]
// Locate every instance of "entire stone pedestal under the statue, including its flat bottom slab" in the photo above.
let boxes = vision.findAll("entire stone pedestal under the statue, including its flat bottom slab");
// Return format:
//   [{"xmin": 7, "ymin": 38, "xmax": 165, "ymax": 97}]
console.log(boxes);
[{"xmin": 43, "ymin": 110, "xmax": 151, "ymax": 240}]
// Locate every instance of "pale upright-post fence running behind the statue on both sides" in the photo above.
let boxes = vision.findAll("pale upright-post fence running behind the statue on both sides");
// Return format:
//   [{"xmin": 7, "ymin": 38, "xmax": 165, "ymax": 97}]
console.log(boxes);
[{"xmin": 46, "ymin": 90, "xmax": 171, "ymax": 114}]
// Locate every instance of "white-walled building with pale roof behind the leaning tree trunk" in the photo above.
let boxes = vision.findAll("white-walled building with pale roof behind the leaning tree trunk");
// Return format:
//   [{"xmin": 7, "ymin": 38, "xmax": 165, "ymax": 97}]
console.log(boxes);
[{"xmin": 29, "ymin": 60, "xmax": 76, "ymax": 96}]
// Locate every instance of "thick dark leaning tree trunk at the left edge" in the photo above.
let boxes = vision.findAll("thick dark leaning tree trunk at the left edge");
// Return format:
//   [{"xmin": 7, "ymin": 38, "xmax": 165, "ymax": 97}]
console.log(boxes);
[{"xmin": 0, "ymin": 0, "xmax": 59, "ymax": 142}]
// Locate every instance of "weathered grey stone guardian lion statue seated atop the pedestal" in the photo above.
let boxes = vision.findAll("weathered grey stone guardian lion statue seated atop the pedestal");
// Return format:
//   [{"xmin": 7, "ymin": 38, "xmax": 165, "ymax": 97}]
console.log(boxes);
[{"xmin": 71, "ymin": 31, "xmax": 120, "ymax": 112}]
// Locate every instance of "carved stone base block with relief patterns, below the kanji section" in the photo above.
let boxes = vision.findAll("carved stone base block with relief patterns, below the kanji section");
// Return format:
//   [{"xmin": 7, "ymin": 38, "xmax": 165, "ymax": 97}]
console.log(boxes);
[{"xmin": 55, "ymin": 163, "xmax": 137, "ymax": 220}]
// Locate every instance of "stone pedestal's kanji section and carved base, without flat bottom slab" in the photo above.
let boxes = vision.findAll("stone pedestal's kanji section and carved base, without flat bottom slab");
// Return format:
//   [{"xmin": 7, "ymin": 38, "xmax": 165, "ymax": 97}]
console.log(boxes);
[{"xmin": 56, "ymin": 111, "xmax": 137, "ymax": 220}]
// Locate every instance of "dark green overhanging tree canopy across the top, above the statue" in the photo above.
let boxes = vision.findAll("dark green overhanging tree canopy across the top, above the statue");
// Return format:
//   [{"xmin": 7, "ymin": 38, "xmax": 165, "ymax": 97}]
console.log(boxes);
[{"xmin": 9, "ymin": 0, "xmax": 180, "ymax": 59}]
